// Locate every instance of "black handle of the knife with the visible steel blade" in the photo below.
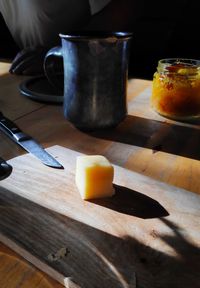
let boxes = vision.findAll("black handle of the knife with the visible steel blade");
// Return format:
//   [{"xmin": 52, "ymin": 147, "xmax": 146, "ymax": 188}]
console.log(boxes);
[{"xmin": 0, "ymin": 112, "xmax": 30, "ymax": 142}]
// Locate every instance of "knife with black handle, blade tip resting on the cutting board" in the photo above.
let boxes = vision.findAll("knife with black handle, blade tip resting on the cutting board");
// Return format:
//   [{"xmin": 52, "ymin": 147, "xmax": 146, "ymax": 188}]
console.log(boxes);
[{"xmin": 0, "ymin": 112, "xmax": 63, "ymax": 169}]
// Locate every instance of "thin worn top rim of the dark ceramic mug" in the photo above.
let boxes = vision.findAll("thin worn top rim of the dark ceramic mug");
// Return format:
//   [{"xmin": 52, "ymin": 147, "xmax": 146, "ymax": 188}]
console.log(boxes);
[{"xmin": 59, "ymin": 30, "xmax": 133, "ymax": 40}]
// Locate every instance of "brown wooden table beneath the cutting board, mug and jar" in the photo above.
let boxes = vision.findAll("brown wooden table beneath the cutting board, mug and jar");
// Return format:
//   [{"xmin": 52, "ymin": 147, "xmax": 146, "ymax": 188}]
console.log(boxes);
[{"xmin": 0, "ymin": 63, "xmax": 200, "ymax": 288}]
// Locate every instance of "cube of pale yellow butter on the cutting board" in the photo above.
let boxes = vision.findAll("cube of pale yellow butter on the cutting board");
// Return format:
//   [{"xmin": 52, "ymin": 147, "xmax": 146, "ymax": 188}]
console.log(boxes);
[{"xmin": 75, "ymin": 155, "xmax": 115, "ymax": 200}]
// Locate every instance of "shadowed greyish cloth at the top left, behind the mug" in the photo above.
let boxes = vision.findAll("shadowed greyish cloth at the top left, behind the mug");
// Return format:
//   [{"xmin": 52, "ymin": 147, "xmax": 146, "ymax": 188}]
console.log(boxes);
[{"xmin": 0, "ymin": 0, "xmax": 111, "ymax": 48}]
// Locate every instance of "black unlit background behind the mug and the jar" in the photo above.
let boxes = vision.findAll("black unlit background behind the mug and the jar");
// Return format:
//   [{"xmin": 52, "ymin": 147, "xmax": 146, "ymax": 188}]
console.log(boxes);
[{"xmin": 0, "ymin": 0, "xmax": 200, "ymax": 79}]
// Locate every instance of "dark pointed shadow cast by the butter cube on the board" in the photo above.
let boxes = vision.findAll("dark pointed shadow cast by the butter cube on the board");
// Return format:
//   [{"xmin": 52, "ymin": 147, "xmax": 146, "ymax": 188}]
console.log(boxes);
[{"xmin": 89, "ymin": 184, "xmax": 169, "ymax": 219}]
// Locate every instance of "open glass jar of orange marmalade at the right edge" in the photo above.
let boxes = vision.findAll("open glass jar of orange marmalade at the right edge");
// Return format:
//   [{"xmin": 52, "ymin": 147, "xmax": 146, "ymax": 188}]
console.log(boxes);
[{"xmin": 151, "ymin": 58, "xmax": 200, "ymax": 121}]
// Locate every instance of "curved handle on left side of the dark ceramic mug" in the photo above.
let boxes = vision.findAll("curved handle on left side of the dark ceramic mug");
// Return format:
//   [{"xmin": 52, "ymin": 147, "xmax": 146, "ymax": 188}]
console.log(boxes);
[{"xmin": 43, "ymin": 46, "xmax": 64, "ymax": 91}]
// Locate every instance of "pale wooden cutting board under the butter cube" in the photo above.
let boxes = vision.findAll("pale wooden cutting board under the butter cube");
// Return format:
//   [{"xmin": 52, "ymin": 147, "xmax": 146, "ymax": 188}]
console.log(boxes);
[{"xmin": 0, "ymin": 146, "xmax": 200, "ymax": 288}]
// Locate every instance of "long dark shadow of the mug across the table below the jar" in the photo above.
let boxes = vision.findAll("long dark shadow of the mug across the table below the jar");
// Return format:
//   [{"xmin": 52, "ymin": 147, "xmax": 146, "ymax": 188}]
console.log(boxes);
[{"xmin": 88, "ymin": 115, "xmax": 200, "ymax": 160}]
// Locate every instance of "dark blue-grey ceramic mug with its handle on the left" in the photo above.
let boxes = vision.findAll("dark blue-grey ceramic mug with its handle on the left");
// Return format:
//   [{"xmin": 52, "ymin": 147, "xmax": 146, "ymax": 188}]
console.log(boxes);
[{"xmin": 44, "ymin": 32, "xmax": 132, "ymax": 130}]
